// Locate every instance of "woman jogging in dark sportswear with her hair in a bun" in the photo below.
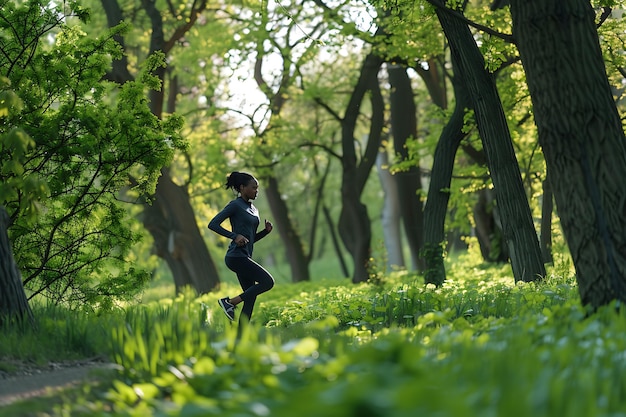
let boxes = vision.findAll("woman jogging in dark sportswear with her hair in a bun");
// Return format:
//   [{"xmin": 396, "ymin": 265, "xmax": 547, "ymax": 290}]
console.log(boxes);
[{"xmin": 209, "ymin": 171, "xmax": 274, "ymax": 323}]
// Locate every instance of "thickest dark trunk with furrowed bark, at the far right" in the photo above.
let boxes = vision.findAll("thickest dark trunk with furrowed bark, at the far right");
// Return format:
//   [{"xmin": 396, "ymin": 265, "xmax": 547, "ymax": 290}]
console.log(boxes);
[{"xmin": 511, "ymin": 0, "xmax": 626, "ymax": 308}]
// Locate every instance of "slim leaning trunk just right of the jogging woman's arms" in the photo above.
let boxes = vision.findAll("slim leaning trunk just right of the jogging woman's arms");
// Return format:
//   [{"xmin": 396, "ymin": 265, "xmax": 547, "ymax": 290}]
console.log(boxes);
[{"xmin": 265, "ymin": 177, "xmax": 311, "ymax": 282}]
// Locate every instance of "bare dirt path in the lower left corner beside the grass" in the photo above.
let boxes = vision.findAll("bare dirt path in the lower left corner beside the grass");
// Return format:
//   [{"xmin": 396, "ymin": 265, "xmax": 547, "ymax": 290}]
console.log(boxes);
[{"xmin": 0, "ymin": 360, "xmax": 113, "ymax": 406}]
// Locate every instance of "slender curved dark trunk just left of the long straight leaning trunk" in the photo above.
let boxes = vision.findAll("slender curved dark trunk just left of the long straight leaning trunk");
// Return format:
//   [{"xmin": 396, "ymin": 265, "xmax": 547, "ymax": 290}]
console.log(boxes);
[{"xmin": 423, "ymin": 62, "xmax": 470, "ymax": 286}]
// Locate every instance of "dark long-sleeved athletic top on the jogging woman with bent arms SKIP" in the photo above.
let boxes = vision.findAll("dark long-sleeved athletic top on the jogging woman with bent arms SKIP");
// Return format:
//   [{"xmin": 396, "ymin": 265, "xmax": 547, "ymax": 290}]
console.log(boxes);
[{"xmin": 209, "ymin": 197, "xmax": 268, "ymax": 257}]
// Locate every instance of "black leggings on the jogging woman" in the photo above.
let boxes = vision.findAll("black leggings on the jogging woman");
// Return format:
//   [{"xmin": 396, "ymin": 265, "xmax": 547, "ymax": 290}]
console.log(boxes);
[{"xmin": 225, "ymin": 256, "xmax": 274, "ymax": 321}]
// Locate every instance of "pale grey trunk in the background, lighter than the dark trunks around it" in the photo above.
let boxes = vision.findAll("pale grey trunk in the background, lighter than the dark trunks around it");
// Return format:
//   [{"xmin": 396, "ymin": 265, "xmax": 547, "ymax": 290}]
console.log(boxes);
[{"xmin": 376, "ymin": 149, "xmax": 405, "ymax": 271}]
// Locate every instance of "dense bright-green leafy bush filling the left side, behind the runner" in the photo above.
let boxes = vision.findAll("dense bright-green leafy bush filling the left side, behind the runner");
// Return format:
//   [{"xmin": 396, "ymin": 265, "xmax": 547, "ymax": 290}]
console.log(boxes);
[{"xmin": 0, "ymin": 0, "xmax": 185, "ymax": 308}]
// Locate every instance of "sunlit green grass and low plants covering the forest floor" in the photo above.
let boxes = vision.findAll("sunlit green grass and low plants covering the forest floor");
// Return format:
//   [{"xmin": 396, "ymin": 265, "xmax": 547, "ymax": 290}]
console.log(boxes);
[{"xmin": 0, "ymin": 249, "xmax": 626, "ymax": 417}]
